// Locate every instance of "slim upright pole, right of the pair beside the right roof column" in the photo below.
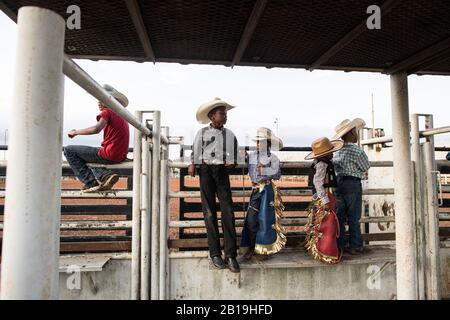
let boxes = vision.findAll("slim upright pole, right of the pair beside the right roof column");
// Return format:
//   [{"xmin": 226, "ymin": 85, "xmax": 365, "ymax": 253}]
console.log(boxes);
[{"xmin": 424, "ymin": 115, "xmax": 442, "ymax": 300}]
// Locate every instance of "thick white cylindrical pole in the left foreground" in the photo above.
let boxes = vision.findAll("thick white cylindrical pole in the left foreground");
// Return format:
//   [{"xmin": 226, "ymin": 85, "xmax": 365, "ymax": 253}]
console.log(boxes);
[{"xmin": 1, "ymin": 7, "xmax": 65, "ymax": 299}]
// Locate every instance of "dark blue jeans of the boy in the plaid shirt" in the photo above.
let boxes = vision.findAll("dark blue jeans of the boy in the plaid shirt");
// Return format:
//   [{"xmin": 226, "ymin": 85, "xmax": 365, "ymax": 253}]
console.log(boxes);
[{"xmin": 334, "ymin": 177, "xmax": 363, "ymax": 249}]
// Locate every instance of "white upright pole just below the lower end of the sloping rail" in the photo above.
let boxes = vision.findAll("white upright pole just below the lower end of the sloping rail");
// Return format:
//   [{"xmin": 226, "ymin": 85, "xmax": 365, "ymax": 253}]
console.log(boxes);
[{"xmin": 141, "ymin": 137, "xmax": 151, "ymax": 300}]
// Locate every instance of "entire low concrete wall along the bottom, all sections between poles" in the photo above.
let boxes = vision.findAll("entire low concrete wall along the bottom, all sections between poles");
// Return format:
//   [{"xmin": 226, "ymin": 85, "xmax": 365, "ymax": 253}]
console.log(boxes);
[{"xmin": 60, "ymin": 248, "xmax": 450, "ymax": 300}]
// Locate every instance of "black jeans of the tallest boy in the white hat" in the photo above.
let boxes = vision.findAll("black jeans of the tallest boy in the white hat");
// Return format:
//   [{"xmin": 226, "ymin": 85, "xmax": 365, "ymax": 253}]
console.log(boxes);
[{"xmin": 199, "ymin": 164, "xmax": 237, "ymax": 258}]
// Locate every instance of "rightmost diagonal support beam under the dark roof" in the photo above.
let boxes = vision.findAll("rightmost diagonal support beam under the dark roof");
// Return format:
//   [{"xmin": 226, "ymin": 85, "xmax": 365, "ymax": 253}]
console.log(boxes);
[{"xmin": 385, "ymin": 37, "xmax": 450, "ymax": 74}]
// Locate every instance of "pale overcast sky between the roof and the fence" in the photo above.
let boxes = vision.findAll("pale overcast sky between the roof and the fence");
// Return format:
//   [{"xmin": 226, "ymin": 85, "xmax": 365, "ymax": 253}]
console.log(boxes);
[{"xmin": 0, "ymin": 12, "xmax": 450, "ymax": 157}]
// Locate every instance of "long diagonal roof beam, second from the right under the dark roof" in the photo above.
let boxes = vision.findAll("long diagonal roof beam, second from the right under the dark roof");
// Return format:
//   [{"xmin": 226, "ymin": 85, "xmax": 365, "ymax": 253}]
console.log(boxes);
[{"xmin": 308, "ymin": 0, "xmax": 401, "ymax": 71}]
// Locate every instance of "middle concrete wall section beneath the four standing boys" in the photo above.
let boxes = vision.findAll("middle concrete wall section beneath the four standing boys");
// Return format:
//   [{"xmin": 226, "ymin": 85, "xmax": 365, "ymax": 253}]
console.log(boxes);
[{"xmin": 171, "ymin": 258, "xmax": 396, "ymax": 299}]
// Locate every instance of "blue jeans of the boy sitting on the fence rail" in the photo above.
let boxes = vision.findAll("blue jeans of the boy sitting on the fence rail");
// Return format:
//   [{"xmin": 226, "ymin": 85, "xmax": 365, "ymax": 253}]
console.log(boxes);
[{"xmin": 64, "ymin": 145, "xmax": 116, "ymax": 185}]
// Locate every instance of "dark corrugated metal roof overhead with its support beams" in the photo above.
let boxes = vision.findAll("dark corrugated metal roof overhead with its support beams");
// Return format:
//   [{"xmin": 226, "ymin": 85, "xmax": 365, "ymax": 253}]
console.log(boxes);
[{"xmin": 0, "ymin": 0, "xmax": 450, "ymax": 74}]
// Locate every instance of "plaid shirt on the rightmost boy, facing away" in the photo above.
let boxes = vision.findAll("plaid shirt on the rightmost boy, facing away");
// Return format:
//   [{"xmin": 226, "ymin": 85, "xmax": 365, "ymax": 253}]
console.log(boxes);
[{"xmin": 333, "ymin": 142, "xmax": 370, "ymax": 179}]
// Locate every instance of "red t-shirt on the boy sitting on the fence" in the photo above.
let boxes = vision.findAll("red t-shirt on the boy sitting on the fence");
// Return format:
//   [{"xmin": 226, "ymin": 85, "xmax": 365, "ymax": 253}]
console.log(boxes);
[{"xmin": 97, "ymin": 109, "xmax": 130, "ymax": 162}]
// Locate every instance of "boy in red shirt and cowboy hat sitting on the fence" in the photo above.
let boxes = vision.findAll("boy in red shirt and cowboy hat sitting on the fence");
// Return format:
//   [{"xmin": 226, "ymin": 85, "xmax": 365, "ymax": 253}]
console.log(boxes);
[{"xmin": 64, "ymin": 84, "xmax": 130, "ymax": 192}]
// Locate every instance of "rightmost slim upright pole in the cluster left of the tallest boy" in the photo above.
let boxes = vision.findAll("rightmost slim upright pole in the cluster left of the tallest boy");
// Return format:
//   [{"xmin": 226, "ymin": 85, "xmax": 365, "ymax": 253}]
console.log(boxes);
[{"xmin": 159, "ymin": 127, "xmax": 170, "ymax": 300}]
